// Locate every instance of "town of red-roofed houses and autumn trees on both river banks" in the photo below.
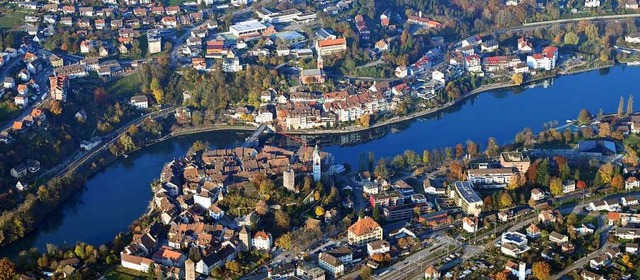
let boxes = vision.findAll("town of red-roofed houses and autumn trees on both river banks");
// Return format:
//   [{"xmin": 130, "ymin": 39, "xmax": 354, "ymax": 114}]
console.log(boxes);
[{"xmin": 0, "ymin": 0, "xmax": 640, "ymax": 279}]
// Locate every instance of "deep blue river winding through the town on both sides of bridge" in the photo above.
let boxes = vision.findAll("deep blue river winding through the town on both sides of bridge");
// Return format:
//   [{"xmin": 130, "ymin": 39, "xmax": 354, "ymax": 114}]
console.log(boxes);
[{"xmin": 0, "ymin": 66, "xmax": 640, "ymax": 256}]
